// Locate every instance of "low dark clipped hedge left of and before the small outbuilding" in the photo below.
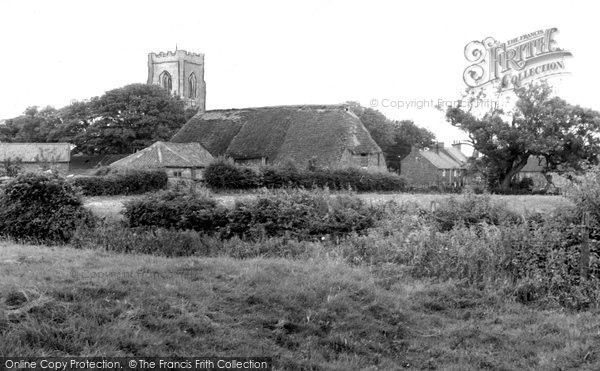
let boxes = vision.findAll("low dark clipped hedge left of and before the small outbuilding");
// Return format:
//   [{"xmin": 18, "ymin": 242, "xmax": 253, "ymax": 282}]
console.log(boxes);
[{"xmin": 72, "ymin": 169, "xmax": 169, "ymax": 196}]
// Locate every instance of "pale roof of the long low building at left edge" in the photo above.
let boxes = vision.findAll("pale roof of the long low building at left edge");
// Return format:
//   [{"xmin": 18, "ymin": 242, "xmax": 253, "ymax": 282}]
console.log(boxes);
[{"xmin": 0, "ymin": 143, "xmax": 71, "ymax": 163}]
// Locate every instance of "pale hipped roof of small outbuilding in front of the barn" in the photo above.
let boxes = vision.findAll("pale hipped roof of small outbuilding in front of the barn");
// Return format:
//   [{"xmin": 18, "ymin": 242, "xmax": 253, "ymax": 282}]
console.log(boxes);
[{"xmin": 110, "ymin": 142, "xmax": 213, "ymax": 169}]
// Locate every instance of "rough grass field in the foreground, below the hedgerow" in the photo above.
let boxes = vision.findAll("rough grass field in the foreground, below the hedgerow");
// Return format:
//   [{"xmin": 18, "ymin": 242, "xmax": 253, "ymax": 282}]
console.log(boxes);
[{"xmin": 0, "ymin": 242, "xmax": 600, "ymax": 370}]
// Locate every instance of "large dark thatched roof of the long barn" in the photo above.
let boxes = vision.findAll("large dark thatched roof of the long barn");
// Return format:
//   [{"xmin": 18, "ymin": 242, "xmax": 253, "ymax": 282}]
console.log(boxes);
[{"xmin": 172, "ymin": 105, "xmax": 381, "ymax": 166}]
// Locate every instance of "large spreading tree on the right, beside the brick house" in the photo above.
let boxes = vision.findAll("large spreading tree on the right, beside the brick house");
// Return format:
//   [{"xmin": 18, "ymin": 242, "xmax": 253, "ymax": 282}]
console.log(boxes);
[{"xmin": 446, "ymin": 81, "xmax": 600, "ymax": 190}]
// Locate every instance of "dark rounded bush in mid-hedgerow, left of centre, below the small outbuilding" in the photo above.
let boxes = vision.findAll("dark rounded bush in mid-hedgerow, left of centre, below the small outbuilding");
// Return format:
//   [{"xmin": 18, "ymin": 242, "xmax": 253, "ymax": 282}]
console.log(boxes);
[{"xmin": 123, "ymin": 189, "xmax": 226, "ymax": 232}]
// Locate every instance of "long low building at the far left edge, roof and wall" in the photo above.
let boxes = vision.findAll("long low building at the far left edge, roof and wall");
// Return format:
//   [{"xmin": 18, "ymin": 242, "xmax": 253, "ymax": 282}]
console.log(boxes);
[{"xmin": 0, "ymin": 143, "xmax": 73, "ymax": 175}]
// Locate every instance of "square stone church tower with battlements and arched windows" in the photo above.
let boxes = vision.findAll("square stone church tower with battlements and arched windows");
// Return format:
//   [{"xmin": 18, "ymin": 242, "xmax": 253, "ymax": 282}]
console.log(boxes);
[{"xmin": 148, "ymin": 50, "xmax": 206, "ymax": 112}]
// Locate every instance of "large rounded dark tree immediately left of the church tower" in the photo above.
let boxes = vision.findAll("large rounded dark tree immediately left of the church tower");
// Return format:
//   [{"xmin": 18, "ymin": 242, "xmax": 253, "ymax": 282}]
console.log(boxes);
[{"xmin": 73, "ymin": 84, "xmax": 186, "ymax": 154}]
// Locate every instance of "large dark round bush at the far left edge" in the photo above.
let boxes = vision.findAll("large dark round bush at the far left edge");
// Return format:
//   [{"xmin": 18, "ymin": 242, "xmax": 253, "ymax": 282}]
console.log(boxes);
[{"xmin": 0, "ymin": 173, "xmax": 94, "ymax": 243}]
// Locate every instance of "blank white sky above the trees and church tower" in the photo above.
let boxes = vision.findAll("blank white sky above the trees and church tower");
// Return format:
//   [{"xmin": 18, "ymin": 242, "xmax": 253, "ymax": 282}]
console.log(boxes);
[{"xmin": 0, "ymin": 0, "xmax": 600, "ymax": 142}]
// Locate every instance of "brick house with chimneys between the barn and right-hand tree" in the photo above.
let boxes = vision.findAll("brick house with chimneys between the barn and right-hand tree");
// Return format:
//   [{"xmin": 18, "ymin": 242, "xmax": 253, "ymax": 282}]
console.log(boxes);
[{"xmin": 400, "ymin": 142, "xmax": 468, "ymax": 187}]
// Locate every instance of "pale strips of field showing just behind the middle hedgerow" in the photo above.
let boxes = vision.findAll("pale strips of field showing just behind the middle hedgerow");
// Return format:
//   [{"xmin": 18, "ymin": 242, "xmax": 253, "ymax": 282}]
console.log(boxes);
[{"xmin": 85, "ymin": 193, "xmax": 570, "ymax": 220}]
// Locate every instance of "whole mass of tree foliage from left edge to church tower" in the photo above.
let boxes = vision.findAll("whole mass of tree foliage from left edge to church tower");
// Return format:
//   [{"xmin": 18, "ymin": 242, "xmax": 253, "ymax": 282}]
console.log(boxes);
[{"xmin": 0, "ymin": 84, "xmax": 189, "ymax": 154}]
